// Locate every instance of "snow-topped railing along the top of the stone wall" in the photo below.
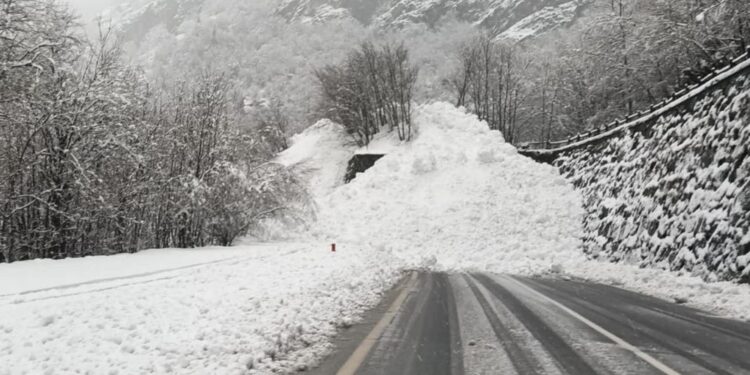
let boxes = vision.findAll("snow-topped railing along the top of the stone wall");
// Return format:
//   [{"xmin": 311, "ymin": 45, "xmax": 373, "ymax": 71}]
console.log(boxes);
[{"xmin": 519, "ymin": 46, "xmax": 750, "ymax": 154}]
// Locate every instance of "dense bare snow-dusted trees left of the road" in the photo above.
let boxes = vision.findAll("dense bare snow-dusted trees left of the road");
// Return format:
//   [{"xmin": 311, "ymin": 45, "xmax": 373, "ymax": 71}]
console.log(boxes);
[{"xmin": 0, "ymin": 0, "xmax": 303, "ymax": 261}]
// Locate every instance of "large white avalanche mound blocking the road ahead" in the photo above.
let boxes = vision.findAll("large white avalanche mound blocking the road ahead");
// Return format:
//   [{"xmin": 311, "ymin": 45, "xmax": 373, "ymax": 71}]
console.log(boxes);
[{"xmin": 313, "ymin": 103, "xmax": 585, "ymax": 274}]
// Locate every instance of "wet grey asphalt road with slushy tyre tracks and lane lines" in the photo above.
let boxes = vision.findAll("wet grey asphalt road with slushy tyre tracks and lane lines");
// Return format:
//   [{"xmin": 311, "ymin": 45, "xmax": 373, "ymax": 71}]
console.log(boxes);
[{"xmin": 310, "ymin": 274, "xmax": 750, "ymax": 375}]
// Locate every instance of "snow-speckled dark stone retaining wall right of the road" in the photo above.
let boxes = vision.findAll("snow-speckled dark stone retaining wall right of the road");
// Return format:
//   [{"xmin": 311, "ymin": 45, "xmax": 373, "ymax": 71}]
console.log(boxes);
[{"xmin": 557, "ymin": 69, "xmax": 750, "ymax": 282}]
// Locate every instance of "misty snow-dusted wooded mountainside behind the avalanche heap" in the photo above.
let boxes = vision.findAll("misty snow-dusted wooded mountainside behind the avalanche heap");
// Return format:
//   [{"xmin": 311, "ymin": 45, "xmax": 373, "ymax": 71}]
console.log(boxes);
[{"xmin": 111, "ymin": 0, "xmax": 750, "ymax": 143}]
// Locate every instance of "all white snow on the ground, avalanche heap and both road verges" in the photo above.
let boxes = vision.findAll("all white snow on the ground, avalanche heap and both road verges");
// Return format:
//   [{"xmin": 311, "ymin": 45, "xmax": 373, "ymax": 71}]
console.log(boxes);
[{"xmin": 0, "ymin": 103, "xmax": 750, "ymax": 374}]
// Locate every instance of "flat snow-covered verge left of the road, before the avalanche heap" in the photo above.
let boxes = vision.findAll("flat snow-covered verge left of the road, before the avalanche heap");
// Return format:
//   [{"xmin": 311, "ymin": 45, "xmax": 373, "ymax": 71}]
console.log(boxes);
[{"xmin": 0, "ymin": 243, "xmax": 400, "ymax": 374}]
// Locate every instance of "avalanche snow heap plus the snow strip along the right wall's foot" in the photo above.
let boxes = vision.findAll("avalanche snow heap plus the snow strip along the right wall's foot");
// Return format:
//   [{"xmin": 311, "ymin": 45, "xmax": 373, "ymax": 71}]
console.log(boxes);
[{"xmin": 289, "ymin": 103, "xmax": 750, "ymax": 319}]
